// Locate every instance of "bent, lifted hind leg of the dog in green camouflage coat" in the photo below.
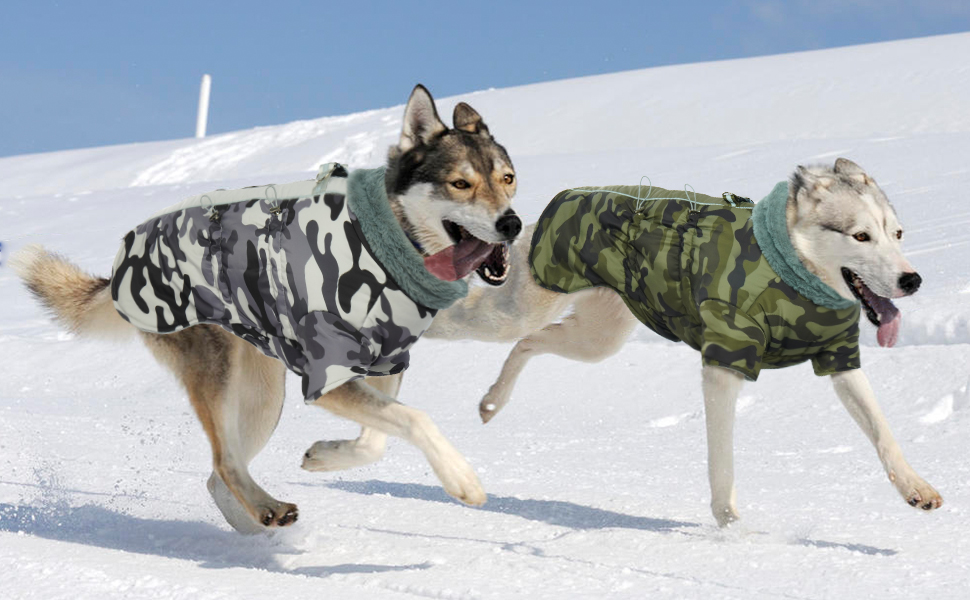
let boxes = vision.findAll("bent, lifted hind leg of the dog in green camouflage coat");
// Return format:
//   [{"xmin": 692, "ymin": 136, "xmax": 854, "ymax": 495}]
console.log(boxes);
[{"xmin": 478, "ymin": 288, "xmax": 638, "ymax": 423}]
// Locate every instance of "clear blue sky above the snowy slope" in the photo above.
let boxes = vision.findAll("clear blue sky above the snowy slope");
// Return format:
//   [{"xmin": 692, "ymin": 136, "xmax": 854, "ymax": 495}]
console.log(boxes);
[{"xmin": 0, "ymin": 0, "xmax": 970, "ymax": 156}]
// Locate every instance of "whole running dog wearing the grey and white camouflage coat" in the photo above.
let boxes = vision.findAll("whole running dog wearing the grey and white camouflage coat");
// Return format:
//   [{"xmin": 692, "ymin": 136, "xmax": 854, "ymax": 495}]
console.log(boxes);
[{"xmin": 16, "ymin": 85, "xmax": 522, "ymax": 532}]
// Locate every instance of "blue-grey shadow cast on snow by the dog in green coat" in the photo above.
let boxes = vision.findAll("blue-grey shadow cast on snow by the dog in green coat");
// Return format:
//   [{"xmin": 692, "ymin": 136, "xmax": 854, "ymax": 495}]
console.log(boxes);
[{"xmin": 325, "ymin": 479, "xmax": 897, "ymax": 556}]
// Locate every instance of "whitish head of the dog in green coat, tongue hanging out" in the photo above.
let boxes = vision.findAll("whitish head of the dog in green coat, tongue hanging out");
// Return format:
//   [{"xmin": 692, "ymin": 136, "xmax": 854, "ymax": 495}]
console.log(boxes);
[{"xmin": 787, "ymin": 158, "xmax": 922, "ymax": 346}]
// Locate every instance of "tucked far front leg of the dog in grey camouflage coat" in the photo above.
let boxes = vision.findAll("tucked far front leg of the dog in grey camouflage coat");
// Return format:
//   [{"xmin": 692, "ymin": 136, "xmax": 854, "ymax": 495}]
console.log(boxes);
[{"xmin": 302, "ymin": 373, "xmax": 396, "ymax": 471}]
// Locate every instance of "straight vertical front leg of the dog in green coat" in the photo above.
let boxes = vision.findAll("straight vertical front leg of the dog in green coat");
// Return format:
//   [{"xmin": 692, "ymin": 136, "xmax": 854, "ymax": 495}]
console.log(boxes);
[{"xmin": 703, "ymin": 366, "xmax": 744, "ymax": 527}]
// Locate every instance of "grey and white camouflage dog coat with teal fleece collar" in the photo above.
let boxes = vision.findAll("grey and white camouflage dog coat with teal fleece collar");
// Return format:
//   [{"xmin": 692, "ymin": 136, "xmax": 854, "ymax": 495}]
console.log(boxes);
[{"xmin": 111, "ymin": 163, "xmax": 467, "ymax": 401}]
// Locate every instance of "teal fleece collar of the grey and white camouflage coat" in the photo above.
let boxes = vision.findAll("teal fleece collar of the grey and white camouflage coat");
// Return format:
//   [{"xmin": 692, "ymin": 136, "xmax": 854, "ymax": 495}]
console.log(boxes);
[{"xmin": 347, "ymin": 167, "xmax": 468, "ymax": 310}]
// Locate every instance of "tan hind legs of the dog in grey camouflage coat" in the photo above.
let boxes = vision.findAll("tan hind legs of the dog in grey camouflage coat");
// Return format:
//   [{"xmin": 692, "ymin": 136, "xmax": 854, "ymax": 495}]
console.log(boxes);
[{"xmin": 144, "ymin": 325, "xmax": 298, "ymax": 533}]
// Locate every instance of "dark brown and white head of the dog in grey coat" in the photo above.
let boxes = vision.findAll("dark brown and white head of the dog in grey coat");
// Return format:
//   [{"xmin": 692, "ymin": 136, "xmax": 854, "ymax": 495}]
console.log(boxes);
[{"xmin": 385, "ymin": 85, "xmax": 522, "ymax": 285}]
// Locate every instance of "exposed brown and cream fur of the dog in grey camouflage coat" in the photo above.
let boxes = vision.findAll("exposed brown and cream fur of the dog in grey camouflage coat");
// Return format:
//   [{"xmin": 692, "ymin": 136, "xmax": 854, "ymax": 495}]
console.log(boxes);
[{"xmin": 15, "ymin": 85, "xmax": 521, "ymax": 533}]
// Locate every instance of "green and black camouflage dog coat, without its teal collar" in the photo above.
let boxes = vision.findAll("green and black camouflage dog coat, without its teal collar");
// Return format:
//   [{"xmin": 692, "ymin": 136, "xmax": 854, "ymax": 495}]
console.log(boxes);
[{"xmin": 529, "ymin": 185, "xmax": 860, "ymax": 381}]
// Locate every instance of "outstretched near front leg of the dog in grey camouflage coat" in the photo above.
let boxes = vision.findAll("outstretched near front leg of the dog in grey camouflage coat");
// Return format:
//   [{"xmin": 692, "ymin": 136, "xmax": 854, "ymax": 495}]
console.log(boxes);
[{"xmin": 313, "ymin": 381, "xmax": 485, "ymax": 506}]
